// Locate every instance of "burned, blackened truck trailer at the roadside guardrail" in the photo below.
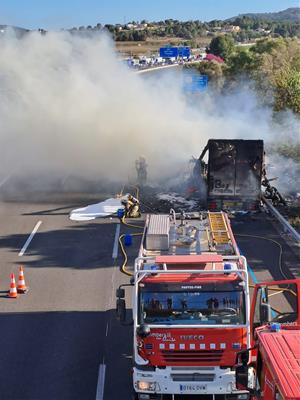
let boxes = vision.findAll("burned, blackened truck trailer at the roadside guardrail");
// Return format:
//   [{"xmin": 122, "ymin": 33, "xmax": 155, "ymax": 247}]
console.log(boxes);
[{"xmin": 196, "ymin": 139, "xmax": 264, "ymax": 210}]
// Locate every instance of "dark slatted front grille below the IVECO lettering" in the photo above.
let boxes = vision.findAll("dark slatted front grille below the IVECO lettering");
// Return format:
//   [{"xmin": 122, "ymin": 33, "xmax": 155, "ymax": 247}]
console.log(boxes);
[{"xmin": 162, "ymin": 350, "xmax": 223, "ymax": 363}]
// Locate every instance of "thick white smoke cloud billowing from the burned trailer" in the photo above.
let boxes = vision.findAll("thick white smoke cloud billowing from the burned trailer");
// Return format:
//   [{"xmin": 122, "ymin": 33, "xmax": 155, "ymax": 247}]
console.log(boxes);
[{"xmin": 0, "ymin": 32, "xmax": 298, "ymax": 192}]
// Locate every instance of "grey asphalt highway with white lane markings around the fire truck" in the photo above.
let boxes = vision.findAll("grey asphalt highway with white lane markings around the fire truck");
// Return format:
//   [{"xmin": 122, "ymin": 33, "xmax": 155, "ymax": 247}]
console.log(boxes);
[{"xmin": 0, "ymin": 180, "xmax": 299, "ymax": 400}]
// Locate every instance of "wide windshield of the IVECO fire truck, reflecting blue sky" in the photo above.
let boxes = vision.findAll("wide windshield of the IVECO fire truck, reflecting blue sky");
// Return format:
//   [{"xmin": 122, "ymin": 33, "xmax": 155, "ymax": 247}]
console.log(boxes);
[{"xmin": 139, "ymin": 283, "xmax": 245, "ymax": 325}]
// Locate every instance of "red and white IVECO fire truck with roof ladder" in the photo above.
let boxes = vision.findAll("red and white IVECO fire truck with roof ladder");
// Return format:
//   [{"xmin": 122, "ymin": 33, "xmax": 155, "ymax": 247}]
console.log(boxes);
[{"xmin": 117, "ymin": 210, "xmax": 250, "ymax": 400}]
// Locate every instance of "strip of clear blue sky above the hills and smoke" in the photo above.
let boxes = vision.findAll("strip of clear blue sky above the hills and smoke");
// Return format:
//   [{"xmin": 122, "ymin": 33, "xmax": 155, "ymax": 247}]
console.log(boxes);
[{"xmin": 0, "ymin": 0, "xmax": 300, "ymax": 30}]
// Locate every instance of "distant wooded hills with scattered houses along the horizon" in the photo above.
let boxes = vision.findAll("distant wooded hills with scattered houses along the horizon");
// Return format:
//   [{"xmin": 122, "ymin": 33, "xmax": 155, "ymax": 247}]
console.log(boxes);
[{"xmin": 70, "ymin": 8, "xmax": 300, "ymax": 43}]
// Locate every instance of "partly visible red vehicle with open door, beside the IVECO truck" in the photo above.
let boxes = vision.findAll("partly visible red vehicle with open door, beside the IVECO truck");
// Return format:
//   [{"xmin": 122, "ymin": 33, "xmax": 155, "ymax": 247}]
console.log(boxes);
[{"xmin": 236, "ymin": 279, "xmax": 300, "ymax": 400}]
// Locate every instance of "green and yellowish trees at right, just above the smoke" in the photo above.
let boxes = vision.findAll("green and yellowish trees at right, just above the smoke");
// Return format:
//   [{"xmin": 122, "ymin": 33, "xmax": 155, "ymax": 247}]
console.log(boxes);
[{"xmin": 192, "ymin": 37, "xmax": 300, "ymax": 115}]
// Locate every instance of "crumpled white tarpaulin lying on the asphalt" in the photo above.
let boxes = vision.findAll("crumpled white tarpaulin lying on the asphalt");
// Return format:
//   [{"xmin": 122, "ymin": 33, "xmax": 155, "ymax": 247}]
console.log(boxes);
[{"xmin": 70, "ymin": 196, "xmax": 126, "ymax": 221}]
